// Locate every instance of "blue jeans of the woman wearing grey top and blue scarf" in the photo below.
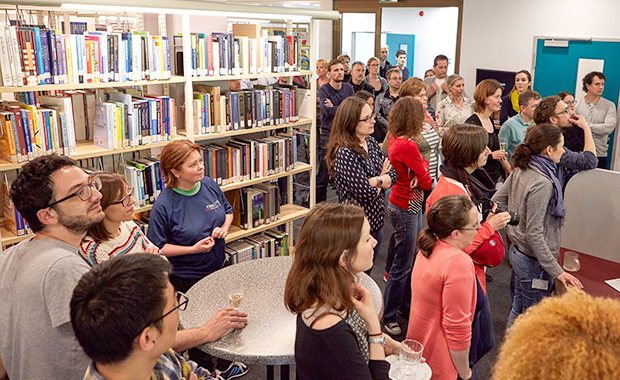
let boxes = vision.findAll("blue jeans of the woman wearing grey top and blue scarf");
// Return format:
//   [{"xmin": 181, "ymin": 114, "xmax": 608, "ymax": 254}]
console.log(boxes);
[{"xmin": 506, "ymin": 244, "xmax": 554, "ymax": 328}]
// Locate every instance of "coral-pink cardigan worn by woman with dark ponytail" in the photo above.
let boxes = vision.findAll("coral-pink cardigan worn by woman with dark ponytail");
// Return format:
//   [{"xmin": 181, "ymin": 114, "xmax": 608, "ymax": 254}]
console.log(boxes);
[{"xmin": 407, "ymin": 240, "xmax": 476, "ymax": 380}]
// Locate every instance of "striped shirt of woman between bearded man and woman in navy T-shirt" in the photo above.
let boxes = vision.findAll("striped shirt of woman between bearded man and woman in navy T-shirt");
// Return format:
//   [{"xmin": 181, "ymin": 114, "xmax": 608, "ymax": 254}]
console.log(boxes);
[{"xmin": 79, "ymin": 221, "xmax": 163, "ymax": 266}]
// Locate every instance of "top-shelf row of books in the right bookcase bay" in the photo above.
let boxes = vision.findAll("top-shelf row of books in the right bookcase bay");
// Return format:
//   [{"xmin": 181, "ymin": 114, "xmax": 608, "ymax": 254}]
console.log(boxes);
[{"xmin": 173, "ymin": 24, "xmax": 302, "ymax": 77}]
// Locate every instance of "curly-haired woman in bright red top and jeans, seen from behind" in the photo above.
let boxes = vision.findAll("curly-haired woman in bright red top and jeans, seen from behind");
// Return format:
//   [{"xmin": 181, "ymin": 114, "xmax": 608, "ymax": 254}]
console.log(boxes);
[{"xmin": 383, "ymin": 96, "xmax": 433, "ymax": 335}]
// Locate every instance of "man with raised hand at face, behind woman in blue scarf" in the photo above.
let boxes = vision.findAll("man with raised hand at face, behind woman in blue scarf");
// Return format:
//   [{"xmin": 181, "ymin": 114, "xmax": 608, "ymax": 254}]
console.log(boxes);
[{"xmin": 534, "ymin": 96, "xmax": 598, "ymax": 188}]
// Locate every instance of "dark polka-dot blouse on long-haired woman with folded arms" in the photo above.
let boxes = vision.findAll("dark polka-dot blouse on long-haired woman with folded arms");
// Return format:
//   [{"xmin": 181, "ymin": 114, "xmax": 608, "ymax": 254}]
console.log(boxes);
[{"xmin": 334, "ymin": 136, "xmax": 396, "ymax": 232}]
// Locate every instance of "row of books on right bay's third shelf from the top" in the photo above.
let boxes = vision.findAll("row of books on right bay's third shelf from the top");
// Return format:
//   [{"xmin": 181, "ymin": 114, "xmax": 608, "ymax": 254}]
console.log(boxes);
[{"xmin": 202, "ymin": 133, "xmax": 297, "ymax": 186}]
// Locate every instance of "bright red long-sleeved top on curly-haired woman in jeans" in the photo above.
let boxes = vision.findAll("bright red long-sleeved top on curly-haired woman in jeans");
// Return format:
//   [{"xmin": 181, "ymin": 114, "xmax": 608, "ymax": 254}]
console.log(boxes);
[{"xmin": 388, "ymin": 136, "xmax": 433, "ymax": 210}]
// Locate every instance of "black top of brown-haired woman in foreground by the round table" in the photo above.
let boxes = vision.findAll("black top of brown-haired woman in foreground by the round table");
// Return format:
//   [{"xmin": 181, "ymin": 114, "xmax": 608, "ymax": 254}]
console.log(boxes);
[{"xmin": 295, "ymin": 314, "xmax": 390, "ymax": 380}]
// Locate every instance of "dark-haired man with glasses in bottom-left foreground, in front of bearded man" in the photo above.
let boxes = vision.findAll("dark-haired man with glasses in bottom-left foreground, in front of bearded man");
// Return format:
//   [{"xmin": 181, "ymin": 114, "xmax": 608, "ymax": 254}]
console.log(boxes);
[{"xmin": 70, "ymin": 253, "xmax": 247, "ymax": 380}]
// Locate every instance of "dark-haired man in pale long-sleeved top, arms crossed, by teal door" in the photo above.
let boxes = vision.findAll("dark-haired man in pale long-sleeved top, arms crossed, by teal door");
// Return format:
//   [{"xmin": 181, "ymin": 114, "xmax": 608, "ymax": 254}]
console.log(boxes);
[{"xmin": 575, "ymin": 71, "xmax": 616, "ymax": 169}]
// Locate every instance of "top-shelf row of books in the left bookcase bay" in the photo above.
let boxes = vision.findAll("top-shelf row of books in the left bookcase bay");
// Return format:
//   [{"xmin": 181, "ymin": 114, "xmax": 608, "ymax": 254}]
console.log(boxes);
[{"xmin": 0, "ymin": 25, "xmax": 171, "ymax": 87}]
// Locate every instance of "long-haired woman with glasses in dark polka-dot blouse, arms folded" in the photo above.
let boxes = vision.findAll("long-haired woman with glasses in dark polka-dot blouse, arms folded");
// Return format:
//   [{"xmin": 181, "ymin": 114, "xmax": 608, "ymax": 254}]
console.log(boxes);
[{"xmin": 325, "ymin": 96, "xmax": 396, "ymax": 273}]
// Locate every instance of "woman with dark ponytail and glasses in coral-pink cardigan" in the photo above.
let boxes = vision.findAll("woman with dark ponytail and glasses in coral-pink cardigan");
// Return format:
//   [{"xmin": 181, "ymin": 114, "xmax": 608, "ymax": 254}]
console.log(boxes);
[{"xmin": 407, "ymin": 195, "xmax": 480, "ymax": 380}]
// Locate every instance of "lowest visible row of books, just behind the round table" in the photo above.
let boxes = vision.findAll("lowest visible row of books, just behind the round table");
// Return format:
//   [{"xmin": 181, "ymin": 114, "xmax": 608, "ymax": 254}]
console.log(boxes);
[{"xmin": 225, "ymin": 229, "xmax": 289, "ymax": 264}]
